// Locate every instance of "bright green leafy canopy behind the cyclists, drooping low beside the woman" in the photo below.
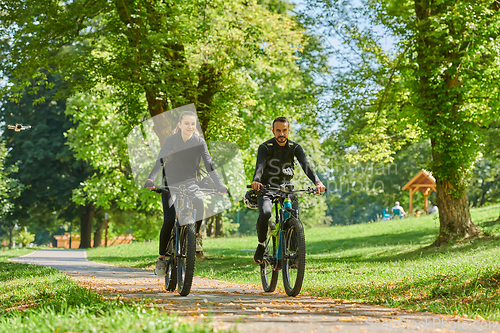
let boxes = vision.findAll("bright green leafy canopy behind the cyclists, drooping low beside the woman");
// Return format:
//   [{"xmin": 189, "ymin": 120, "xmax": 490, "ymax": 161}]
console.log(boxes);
[{"xmin": 0, "ymin": 0, "xmax": 332, "ymax": 243}]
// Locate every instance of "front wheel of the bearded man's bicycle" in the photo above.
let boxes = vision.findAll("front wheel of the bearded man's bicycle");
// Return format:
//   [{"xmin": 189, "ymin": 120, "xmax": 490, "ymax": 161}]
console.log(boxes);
[{"xmin": 282, "ymin": 217, "xmax": 306, "ymax": 296}]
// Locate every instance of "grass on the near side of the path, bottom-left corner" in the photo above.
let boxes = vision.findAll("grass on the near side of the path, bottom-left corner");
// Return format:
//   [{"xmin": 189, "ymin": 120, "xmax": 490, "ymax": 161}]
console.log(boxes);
[{"xmin": 0, "ymin": 249, "xmax": 221, "ymax": 333}]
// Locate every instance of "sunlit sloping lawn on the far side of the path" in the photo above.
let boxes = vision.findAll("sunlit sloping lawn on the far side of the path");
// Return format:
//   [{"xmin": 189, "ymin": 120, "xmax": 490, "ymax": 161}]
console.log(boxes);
[{"xmin": 88, "ymin": 205, "xmax": 500, "ymax": 320}]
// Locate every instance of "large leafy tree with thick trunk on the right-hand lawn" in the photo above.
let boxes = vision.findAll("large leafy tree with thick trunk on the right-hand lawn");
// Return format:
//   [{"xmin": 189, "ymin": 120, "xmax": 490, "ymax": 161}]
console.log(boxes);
[{"xmin": 308, "ymin": 0, "xmax": 500, "ymax": 245}]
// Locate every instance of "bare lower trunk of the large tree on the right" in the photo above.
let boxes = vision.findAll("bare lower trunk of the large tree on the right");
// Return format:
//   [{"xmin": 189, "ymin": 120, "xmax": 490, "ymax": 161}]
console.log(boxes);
[{"xmin": 434, "ymin": 179, "xmax": 478, "ymax": 246}]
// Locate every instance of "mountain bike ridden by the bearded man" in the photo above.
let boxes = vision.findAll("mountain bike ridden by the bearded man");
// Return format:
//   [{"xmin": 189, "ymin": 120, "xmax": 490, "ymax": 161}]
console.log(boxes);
[{"xmin": 247, "ymin": 184, "xmax": 317, "ymax": 296}]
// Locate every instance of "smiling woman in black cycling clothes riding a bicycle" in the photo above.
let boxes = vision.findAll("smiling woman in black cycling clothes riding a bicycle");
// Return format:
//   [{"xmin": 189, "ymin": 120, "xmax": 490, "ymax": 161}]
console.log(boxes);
[{"xmin": 145, "ymin": 111, "xmax": 227, "ymax": 276}]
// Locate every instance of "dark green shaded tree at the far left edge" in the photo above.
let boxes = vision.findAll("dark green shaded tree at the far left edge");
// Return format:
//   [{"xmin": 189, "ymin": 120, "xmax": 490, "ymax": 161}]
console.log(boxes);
[{"xmin": 0, "ymin": 76, "xmax": 89, "ymax": 246}]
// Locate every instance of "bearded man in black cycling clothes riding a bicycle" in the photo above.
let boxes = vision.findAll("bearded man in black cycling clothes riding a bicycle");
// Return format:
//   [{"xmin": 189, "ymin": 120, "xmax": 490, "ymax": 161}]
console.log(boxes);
[{"xmin": 252, "ymin": 117, "xmax": 325, "ymax": 265}]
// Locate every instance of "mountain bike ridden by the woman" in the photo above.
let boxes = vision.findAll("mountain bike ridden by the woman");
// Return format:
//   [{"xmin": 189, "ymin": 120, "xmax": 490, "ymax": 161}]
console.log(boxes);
[{"xmin": 155, "ymin": 185, "xmax": 217, "ymax": 296}]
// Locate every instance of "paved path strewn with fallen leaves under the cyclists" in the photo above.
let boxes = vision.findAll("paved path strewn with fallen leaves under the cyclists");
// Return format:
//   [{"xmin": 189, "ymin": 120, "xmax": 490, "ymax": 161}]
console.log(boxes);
[{"xmin": 11, "ymin": 249, "xmax": 500, "ymax": 333}]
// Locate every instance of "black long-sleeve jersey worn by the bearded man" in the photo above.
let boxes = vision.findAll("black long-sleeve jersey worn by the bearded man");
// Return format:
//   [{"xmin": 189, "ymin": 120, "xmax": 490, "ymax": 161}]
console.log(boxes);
[{"xmin": 253, "ymin": 138, "xmax": 320, "ymax": 186}]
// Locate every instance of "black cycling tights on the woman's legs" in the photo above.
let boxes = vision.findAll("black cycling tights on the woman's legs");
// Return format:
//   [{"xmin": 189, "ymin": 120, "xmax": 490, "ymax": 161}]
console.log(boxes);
[{"xmin": 159, "ymin": 192, "xmax": 205, "ymax": 256}]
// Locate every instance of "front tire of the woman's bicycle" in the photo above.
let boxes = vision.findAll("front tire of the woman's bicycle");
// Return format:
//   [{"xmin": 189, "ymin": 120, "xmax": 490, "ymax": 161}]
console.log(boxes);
[{"xmin": 177, "ymin": 218, "xmax": 196, "ymax": 296}]
